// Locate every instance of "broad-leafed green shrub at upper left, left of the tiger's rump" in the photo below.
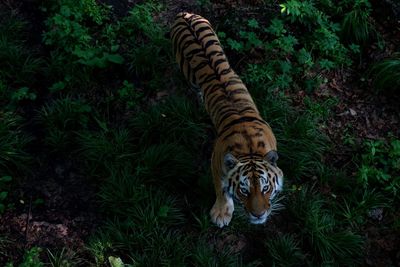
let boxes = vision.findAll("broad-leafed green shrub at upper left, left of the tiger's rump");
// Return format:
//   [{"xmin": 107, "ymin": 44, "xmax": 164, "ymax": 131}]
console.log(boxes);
[{"xmin": 43, "ymin": 0, "xmax": 124, "ymax": 88}]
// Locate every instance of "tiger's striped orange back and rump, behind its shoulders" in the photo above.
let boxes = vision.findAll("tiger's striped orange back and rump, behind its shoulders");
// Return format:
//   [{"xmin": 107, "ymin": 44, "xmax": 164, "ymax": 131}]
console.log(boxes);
[{"xmin": 171, "ymin": 13, "xmax": 264, "ymax": 135}]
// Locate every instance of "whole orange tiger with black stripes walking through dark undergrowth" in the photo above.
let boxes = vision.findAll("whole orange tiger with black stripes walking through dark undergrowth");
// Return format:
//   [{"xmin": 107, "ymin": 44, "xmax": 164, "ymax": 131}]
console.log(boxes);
[{"xmin": 169, "ymin": 12, "xmax": 283, "ymax": 228}]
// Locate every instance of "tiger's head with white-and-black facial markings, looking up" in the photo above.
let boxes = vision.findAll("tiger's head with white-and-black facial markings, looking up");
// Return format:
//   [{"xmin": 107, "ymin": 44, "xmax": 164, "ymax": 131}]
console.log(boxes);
[{"xmin": 224, "ymin": 150, "xmax": 283, "ymax": 224}]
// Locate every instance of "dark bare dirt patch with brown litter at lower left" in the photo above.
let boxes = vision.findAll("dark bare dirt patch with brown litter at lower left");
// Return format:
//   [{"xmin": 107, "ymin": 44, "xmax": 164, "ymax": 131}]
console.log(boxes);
[{"xmin": 0, "ymin": 158, "xmax": 101, "ymax": 262}]
